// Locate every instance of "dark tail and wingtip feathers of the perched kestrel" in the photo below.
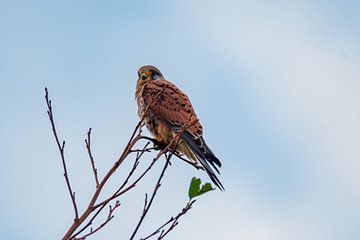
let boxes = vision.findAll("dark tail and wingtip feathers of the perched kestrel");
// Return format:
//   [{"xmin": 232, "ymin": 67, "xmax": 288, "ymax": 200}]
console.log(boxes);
[{"xmin": 182, "ymin": 132, "xmax": 224, "ymax": 191}]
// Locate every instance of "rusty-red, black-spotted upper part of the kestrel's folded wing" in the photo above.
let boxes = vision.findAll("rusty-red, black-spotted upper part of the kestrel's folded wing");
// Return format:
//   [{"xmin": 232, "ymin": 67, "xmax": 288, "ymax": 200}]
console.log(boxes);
[{"xmin": 143, "ymin": 80, "xmax": 202, "ymax": 137}]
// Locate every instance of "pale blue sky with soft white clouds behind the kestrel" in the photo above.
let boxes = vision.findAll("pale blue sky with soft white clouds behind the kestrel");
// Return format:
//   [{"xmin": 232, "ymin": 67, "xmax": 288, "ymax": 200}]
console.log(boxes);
[{"xmin": 0, "ymin": 0, "xmax": 360, "ymax": 240}]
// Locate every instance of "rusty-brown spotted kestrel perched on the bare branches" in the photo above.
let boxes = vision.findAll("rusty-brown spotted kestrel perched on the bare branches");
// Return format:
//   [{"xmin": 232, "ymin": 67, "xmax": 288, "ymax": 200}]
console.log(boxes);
[{"xmin": 135, "ymin": 65, "xmax": 224, "ymax": 191}]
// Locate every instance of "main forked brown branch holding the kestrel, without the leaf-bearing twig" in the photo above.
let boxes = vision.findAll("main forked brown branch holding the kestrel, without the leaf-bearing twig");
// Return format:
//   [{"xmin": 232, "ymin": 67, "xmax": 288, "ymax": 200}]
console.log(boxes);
[{"xmin": 45, "ymin": 88, "xmax": 197, "ymax": 240}]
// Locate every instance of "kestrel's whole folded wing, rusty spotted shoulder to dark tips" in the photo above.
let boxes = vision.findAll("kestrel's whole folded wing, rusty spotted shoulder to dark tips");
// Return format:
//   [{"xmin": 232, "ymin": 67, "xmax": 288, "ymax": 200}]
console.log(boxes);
[{"xmin": 143, "ymin": 79, "xmax": 224, "ymax": 189}]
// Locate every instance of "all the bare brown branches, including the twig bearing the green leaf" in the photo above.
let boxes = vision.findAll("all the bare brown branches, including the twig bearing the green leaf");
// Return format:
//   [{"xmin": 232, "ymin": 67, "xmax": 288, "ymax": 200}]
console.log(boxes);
[{"xmin": 45, "ymin": 88, "xmax": 197, "ymax": 240}]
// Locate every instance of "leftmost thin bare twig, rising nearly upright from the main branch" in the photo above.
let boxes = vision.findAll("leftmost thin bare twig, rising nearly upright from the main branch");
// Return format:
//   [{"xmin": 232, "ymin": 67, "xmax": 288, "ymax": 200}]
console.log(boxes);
[{"xmin": 45, "ymin": 88, "xmax": 79, "ymax": 221}]
